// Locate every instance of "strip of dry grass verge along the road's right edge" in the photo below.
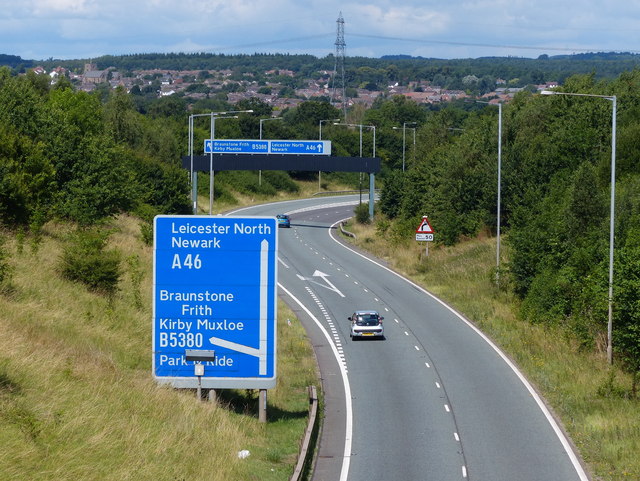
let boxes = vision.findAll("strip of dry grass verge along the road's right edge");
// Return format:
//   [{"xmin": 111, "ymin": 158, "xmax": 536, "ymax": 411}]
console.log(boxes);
[{"xmin": 347, "ymin": 219, "xmax": 640, "ymax": 481}]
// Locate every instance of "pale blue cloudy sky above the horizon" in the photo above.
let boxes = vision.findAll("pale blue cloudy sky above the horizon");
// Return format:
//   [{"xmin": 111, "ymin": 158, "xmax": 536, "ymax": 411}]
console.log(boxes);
[{"xmin": 0, "ymin": 0, "xmax": 640, "ymax": 60}]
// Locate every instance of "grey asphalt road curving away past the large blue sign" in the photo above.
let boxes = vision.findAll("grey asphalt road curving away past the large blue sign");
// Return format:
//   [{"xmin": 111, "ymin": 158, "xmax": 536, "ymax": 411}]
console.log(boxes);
[{"xmin": 233, "ymin": 196, "xmax": 588, "ymax": 481}]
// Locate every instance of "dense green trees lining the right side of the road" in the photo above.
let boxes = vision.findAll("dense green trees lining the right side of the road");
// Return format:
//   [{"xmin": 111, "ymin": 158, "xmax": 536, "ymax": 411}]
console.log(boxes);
[{"xmin": 380, "ymin": 70, "xmax": 640, "ymax": 386}]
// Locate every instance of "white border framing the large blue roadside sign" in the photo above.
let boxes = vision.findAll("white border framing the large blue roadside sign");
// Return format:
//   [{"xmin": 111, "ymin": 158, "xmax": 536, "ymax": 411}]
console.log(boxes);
[{"xmin": 151, "ymin": 215, "xmax": 278, "ymax": 389}]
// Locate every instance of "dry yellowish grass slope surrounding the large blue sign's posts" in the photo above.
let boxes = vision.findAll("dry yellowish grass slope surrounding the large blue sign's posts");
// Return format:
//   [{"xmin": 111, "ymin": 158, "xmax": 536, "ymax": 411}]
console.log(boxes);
[{"xmin": 0, "ymin": 217, "xmax": 318, "ymax": 481}]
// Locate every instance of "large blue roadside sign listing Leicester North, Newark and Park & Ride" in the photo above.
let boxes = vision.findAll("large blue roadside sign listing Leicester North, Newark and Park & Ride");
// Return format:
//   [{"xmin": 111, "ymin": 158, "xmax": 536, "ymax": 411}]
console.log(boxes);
[{"xmin": 152, "ymin": 216, "xmax": 278, "ymax": 389}]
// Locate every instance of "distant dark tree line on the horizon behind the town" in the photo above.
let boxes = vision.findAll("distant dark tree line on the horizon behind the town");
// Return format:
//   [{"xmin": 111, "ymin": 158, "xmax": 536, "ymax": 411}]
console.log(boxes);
[{"xmin": 0, "ymin": 52, "xmax": 640, "ymax": 94}]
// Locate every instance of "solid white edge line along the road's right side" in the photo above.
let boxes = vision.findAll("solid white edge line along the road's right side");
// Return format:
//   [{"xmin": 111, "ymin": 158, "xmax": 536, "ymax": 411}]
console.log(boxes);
[{"xmin": 328, "ymin": 217, "xmax": 589, "ymax": 481}]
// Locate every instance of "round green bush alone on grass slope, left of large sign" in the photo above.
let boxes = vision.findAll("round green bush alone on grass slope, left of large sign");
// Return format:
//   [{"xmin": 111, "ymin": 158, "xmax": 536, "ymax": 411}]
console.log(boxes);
[{"xmin": 61, "ymin": 230, "xmax": 122, "ymax": 295}]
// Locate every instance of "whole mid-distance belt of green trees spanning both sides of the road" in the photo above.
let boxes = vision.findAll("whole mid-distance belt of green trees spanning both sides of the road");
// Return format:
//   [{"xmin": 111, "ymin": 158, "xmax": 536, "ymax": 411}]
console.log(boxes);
[{"xmin": 0, "ymin": 61, "xmax": 640, "ymax": 386}]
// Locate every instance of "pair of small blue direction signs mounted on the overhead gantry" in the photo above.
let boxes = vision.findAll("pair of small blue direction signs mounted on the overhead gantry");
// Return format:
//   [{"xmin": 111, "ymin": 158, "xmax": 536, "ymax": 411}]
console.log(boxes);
[{"xmin": 204, "ymin": 139, "xmax": 331, "ymax": 155}]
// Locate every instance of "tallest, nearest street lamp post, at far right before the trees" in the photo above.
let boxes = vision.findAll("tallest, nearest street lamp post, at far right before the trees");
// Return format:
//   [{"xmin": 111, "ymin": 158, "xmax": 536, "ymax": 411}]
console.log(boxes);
[{"xmin": 540, "ymin": 90, "xmax": 618, "ymax": 364}]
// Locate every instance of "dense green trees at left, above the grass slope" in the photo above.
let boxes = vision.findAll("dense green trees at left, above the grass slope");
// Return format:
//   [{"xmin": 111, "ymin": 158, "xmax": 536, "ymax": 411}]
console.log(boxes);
[{"xmin": 0, "ymin": 68, "xmax": 189, "ymax": 226}]
